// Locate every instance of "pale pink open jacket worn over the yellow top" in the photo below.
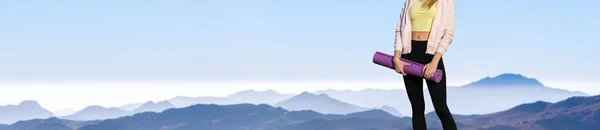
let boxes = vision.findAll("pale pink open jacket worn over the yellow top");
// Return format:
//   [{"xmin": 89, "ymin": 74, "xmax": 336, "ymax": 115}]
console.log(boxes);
[{"xmin": 394, "ymin": 0, "xmax": 454, "ymax": 55}]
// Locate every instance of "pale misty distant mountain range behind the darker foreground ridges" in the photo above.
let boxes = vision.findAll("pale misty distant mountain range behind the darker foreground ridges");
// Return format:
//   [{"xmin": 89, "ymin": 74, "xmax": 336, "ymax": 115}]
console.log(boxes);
[{"xmin": 0, "ymin": 73, "xmax": 587, "ymax": 128}]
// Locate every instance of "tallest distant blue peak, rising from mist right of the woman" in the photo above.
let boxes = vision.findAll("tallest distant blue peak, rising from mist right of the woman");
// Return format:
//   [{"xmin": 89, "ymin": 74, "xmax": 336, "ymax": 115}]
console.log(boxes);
[{"xmin": 465, "ymin": 73, "xmax": 544, "ymax": 87}]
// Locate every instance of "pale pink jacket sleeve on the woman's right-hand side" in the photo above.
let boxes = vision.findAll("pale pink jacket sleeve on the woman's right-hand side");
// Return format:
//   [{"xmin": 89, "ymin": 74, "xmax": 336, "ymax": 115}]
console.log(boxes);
[{"xmin": 436, "ymin": 0, "xmax": 455, "ymax": 54}]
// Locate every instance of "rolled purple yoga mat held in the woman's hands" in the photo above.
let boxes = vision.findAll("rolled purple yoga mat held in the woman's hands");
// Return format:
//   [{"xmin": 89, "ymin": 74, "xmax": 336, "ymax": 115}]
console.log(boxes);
[{"xmin": 373, "ymin": 52, "xmax": 444, "ymax": 83}]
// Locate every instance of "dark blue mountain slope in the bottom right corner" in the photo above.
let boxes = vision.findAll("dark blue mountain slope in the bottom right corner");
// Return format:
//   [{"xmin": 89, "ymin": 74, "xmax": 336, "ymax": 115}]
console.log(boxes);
[{"xmin": 458, "ymin": 95, "xmax": 600, "ymax": 130}]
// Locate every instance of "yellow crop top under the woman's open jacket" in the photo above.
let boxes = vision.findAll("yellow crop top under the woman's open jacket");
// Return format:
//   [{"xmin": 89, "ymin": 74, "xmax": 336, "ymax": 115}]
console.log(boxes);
[{"xmin": 410, "ymin": 0, "xmax": 437, "ymax": 32}]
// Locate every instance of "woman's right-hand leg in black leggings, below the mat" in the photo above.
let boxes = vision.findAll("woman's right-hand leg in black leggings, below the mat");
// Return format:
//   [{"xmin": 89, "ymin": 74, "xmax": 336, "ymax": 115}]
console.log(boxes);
[{"xmin": 426, "ymin": 56, "xmax": 458, "ymax": 130}]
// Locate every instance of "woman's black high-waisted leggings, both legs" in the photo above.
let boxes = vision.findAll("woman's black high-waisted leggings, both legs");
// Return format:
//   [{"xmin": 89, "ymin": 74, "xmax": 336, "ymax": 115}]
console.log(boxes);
[{"xmin": 401, "ymin": 40, "xmax": 457, "ymax": 130}]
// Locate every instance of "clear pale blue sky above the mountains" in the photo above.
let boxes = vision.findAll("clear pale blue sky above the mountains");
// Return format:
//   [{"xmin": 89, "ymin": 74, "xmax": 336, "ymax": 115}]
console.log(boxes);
[{"xmin": 0, "ymin": 0, "xmax": 600, "ymax": 81}]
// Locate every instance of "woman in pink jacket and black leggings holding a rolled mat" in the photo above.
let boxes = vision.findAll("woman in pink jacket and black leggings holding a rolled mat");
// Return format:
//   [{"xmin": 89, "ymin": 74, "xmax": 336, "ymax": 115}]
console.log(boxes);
[{"xmin": 393, "ymin": 0, "xmax": 457, "ymax": 130}]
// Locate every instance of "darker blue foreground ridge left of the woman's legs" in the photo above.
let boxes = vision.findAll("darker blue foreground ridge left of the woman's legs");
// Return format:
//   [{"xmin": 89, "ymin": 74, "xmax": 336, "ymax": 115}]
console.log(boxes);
[{"xmin": 0, "ymin": 104, "xmax": 408, "ymax": 130}]
